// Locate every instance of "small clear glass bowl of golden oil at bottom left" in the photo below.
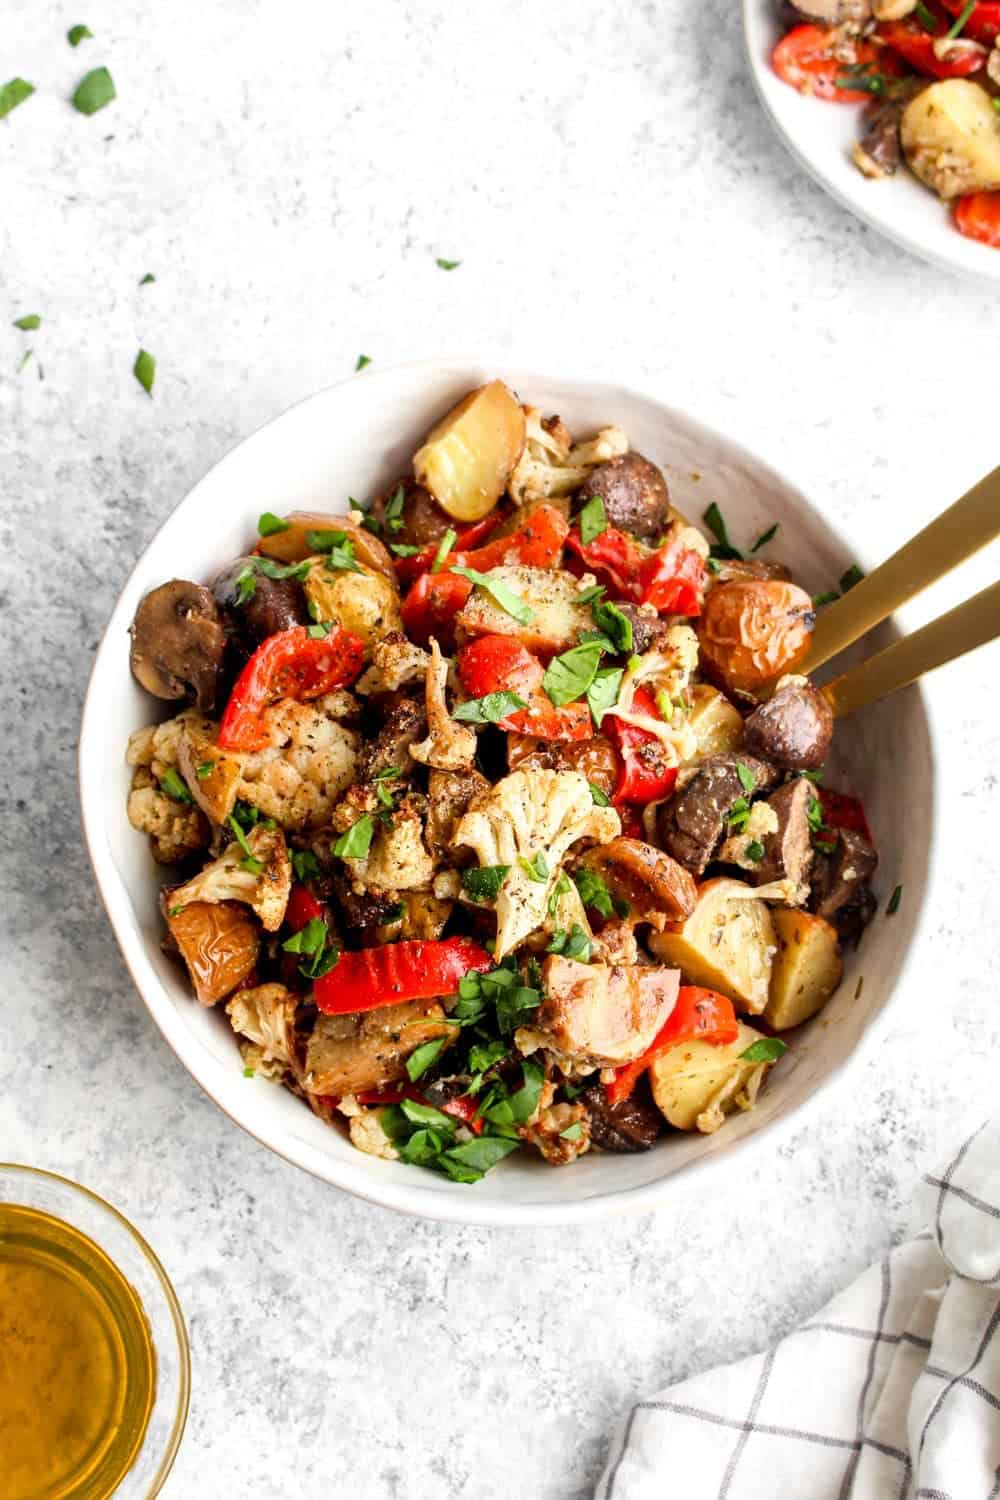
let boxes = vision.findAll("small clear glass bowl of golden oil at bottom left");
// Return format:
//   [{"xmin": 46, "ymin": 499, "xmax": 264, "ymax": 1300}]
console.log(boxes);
[{"xmin": 0, "ymin": 1164, "xmax": 190, "ymax": 1500}]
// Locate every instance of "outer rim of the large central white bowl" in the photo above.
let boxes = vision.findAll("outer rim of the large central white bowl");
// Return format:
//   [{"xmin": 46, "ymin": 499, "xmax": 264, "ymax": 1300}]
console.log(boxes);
[{"xmin": 76, "ymin": 357, "xmax": 943, "ymax": 1229}]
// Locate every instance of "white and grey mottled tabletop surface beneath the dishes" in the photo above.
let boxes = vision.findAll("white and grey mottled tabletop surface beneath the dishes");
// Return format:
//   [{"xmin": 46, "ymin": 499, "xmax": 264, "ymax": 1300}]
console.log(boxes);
[{"xmin": 0, "ymin": 0, "xmax": 1000, "ymax": 1500}]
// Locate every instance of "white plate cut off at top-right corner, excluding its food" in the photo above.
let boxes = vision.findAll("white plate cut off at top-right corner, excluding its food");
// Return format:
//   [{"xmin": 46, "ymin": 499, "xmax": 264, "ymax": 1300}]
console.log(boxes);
[{"xmin": 744, "ymin": 0, "xmax": 1000, "ymax": 282}]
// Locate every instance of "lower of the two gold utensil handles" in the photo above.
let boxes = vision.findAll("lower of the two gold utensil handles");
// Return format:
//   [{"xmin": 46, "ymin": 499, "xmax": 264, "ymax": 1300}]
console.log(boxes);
[{"xmin": 822, "ymin": 582, "xmax": 1000, "ymax": 719}]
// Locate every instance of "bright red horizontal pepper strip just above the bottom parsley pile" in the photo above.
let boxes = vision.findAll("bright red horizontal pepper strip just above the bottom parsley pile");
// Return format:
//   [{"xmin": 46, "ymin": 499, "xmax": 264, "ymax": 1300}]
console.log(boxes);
[{"xmin": 313, "ymin": 938, "xmax": 493, "ymax": 1016}]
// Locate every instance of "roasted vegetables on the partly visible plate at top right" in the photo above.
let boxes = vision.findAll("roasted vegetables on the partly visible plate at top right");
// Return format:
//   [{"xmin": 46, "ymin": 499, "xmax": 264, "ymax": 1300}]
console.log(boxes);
[{"xmin": 772, "ymin": 0, "xmax": 1000, "ymax": 249}]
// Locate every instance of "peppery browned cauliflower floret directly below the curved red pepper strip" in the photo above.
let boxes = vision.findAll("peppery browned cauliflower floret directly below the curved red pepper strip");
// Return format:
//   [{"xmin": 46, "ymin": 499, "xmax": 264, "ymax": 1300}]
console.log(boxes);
[{"xmin": 238, "ymin": 693, "xmax": 360, "ymax": 828}]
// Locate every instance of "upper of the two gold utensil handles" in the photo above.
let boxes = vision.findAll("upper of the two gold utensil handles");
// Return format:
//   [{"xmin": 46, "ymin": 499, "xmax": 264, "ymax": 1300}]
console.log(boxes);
[{"xmin": 798, "ymin": 468, "xmax": 1000, "ymax": 672}]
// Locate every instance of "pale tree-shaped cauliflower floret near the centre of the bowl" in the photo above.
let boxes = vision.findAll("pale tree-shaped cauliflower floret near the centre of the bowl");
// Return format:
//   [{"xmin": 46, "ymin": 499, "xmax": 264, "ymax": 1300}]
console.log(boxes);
[{"xmin": 454, "ymin": 770, "xmax": 621, "ymax": 960}]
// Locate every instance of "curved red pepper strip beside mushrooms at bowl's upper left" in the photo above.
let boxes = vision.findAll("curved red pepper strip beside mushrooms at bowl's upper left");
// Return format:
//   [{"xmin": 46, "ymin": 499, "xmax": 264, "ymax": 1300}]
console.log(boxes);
[{"xmin": 219, "ymin": 626, "xmax": 364, "ymax": 750}]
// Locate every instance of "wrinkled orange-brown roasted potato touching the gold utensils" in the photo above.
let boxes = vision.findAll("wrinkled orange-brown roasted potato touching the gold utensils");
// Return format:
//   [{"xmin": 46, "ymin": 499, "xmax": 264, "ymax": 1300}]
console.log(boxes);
[{"xmin": 699, "ymin": 579, "xmax": 816, "ymax": 693}]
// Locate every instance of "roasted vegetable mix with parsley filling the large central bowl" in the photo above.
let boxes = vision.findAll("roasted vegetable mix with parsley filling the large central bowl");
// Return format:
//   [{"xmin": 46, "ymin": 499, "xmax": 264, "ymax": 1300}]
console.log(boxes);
[{"xmin": 127, "ymin": 381, "xmax": 876, "ymax": 1182}]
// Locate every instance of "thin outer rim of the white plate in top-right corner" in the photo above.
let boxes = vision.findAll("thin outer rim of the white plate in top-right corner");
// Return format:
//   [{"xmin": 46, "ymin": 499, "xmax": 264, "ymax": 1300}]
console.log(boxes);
[{"xmin": 742, "ymin": 0, "xmax": 1000, "ymax": 288}]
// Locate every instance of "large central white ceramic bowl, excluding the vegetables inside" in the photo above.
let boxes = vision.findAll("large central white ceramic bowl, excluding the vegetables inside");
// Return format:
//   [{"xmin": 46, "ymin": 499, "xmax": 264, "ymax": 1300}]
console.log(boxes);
[{"xmin": 79, "ymin": 360, "xmax": 934, "ymax": 1226}]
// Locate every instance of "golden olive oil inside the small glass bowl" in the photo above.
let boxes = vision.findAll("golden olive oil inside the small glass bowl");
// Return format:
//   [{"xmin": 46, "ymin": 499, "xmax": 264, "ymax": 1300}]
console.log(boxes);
[{"xmin": 0, "ymin": 1203, "xmax": 156, "ymax": 1500}]
